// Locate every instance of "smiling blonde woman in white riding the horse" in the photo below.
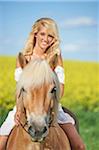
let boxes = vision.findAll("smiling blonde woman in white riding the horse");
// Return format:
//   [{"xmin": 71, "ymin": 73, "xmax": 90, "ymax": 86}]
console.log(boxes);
[{"xmin": 0, "ymin": 18, "xmax": 85, "ymax": 150}]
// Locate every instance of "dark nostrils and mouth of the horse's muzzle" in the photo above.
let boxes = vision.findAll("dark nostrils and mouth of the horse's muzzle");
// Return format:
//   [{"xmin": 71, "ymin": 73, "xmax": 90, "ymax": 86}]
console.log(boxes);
[{"xmin": 28, "ymin": 126, "xmax": 48, "ymax": 142}]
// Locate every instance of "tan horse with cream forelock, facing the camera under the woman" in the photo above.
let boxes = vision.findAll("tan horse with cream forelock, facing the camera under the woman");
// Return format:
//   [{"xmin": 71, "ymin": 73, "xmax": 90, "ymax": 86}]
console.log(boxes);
[{"xmin": 6, "ymin": 59, "xmax": 71, "ymax": 150}]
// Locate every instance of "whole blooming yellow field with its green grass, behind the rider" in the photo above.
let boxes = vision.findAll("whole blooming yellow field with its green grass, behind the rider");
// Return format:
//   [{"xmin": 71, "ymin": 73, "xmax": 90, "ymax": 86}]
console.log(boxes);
[{"xmin": 0, "ymin": 56, "xmax": 99, "ymax": 150}]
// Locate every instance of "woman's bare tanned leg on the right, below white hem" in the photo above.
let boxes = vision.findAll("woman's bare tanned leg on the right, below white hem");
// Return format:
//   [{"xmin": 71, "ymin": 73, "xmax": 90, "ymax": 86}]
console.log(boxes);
[{"xmin": 60, "ymin": 123, "xmax": 86, "ymax": 150}]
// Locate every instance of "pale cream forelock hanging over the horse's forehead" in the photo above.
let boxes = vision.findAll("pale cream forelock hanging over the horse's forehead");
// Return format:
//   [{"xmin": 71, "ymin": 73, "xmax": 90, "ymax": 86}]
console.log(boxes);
[{"xmin": 17, "ymin": 59, "xmax": 54, "ymax": 89}]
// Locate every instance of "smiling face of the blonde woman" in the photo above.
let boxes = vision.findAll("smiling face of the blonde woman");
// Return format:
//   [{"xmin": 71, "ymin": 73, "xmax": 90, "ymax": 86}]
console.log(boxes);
[{"xmin": 35, "ymin": 26, "xmax": 54, "ymax": 52}]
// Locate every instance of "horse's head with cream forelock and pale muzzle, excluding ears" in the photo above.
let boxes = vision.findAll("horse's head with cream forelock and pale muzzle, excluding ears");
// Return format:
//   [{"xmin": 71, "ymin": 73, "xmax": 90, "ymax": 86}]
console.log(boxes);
[{"xmin": 17, "ymin": 59, "xmax": 59, "ymax": 141}]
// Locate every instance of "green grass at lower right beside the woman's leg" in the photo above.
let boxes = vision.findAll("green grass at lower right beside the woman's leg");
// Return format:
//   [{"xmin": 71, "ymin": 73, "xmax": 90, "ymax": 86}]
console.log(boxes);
[{"xmin": 76, "ymin": 110, "xmax": 99, "ymax": 150}]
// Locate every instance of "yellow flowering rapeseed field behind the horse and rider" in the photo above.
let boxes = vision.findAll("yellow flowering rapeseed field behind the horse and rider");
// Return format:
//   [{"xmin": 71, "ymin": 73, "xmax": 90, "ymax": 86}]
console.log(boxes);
[{"xmin": 0, "ymin": 56, "xmax": 99, "ymax": 111}]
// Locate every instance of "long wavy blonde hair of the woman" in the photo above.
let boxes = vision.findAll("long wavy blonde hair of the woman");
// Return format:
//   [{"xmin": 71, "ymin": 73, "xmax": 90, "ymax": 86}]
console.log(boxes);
[{"xmin": 23, "ymin": 18, "xmax": 60, "ymax": 68}]
